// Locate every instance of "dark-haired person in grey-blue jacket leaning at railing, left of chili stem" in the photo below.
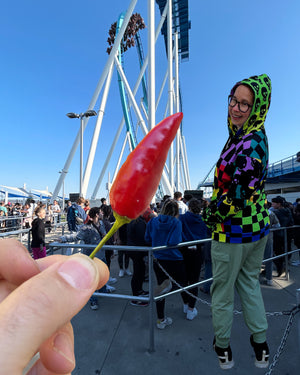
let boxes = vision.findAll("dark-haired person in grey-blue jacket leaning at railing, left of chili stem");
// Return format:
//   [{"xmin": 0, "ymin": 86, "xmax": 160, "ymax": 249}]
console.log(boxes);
[{"xmin": 60, "ymin": 207, "xmax": 115, "ymax": 310}]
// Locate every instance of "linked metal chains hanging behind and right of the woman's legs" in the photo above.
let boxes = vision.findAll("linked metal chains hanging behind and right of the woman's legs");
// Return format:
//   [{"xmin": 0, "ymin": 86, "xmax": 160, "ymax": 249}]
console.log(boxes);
[{"xmin": 154, "ymin": 259, "xmax": 300, "ymax": 375}]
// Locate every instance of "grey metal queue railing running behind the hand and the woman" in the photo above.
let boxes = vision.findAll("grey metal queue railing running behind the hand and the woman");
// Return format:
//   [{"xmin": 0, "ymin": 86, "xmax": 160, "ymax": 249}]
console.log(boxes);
[{"xmin": 49, "ymin": 225, "xmax": 300, "ymax": 352}]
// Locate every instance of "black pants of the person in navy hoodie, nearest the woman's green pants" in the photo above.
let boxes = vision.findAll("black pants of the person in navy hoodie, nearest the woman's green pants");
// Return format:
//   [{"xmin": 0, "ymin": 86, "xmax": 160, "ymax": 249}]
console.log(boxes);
[{"xmin": 180, "ymin": 245, "xmax": 203, "ymax": 308}]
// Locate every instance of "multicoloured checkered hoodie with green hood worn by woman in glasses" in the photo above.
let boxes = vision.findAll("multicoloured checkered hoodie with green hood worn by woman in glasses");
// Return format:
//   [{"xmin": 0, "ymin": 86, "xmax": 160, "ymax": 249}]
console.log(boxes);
[{"xmin": 203, "ymin": 74, "xmax": 271, "ymax": 243}]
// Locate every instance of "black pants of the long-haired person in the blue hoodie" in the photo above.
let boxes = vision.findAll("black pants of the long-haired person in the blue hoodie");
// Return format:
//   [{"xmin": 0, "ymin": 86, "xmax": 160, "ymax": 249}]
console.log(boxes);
[{"xmin": 153, "ymin": 259, "xmax": 189, "ymax": 320}]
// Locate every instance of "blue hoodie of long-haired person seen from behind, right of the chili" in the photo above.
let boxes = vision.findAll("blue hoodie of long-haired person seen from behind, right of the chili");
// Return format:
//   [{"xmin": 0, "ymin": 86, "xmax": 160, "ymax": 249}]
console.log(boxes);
[{"xmin": 145, "ymin": 215, "xmax": 183, "ymax": 260}]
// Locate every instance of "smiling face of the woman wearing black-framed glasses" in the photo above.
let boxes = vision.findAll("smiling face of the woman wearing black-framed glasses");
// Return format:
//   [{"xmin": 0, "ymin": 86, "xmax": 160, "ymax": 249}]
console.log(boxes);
[{"xmin": 228, "ymin": 85, "xmax": 254, "ymax": 129}]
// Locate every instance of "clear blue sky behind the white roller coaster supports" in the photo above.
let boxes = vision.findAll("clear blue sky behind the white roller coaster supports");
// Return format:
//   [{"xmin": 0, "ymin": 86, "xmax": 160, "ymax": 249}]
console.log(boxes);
[{"xmin": 0, "ymin": 0, "xmax": 300, "ymax": 197}]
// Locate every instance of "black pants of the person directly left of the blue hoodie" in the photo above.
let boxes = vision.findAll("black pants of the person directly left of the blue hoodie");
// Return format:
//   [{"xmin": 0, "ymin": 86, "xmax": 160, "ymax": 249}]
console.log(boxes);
[{"xmin": 129, "ymin": 251, "xmax": 148, "ymax": 296}]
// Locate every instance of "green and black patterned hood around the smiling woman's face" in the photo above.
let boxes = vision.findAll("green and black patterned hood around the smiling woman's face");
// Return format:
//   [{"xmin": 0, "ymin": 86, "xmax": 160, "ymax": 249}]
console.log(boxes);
[{"xmin": 227, "ymin": 74, "xmax": 271, "ymax": 136}]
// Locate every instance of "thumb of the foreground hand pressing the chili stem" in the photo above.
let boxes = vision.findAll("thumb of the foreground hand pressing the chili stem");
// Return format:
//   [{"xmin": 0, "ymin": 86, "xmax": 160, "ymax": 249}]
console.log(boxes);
[{"xmin": 0, "ymin": 254, "xmax": 109, "ymax": 374}]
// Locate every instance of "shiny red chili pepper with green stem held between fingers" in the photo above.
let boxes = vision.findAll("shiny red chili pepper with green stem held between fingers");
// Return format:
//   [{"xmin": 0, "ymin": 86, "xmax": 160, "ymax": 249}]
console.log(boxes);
[{"xmin": 90, "ymin": 112, "xmax": 183, "ymax": 258}]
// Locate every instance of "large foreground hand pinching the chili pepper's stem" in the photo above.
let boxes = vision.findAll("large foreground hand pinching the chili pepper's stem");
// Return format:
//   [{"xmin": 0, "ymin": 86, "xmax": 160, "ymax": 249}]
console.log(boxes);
[{"xmin": 0, "ymin": 239, "xmax": 109, "ymax": 375}]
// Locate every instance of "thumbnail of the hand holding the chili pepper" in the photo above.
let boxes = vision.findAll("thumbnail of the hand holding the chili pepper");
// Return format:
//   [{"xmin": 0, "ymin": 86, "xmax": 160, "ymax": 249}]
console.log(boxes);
[{"xmin": 57, "ymin": 254, "xmax": 98, "ymax": 289}]
